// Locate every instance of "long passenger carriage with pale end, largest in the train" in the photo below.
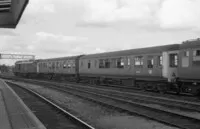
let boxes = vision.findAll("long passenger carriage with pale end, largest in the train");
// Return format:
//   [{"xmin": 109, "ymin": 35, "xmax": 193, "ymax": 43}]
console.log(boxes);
[{"xmin": 79, "ymin": 44, "xmax": 179, "ymax": 91}]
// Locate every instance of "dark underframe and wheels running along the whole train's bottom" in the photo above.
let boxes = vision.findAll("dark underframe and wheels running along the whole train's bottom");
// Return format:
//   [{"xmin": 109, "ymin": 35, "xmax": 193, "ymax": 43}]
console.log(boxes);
[{"xmin": 12, "ymin": 73, "xmax": 200, "ymax": 96}]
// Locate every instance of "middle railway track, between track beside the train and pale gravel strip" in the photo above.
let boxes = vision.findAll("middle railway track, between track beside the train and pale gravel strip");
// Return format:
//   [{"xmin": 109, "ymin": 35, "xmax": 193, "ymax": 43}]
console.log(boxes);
[{"xmin": 9, "ymin": 76, "xmax": 200, "ymax": 112}]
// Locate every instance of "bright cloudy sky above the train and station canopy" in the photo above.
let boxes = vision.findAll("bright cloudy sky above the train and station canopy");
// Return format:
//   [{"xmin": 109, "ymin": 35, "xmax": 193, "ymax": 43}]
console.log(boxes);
[{"xmin": 0, "ymin": 0, "xmax": 200, "ymax": 64}]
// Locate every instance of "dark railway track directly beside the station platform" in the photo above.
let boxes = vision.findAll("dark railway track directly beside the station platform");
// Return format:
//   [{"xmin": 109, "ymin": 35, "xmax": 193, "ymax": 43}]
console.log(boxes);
[{"xmin": 6, "ymin": 82, "xmax": 95, "ymax": 129}]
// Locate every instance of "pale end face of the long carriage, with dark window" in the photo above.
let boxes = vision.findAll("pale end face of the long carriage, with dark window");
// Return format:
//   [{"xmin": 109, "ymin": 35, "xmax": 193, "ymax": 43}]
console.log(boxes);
[{"xmin": 162, "ymin": 51, "xmax": 178, "ymax": 82}]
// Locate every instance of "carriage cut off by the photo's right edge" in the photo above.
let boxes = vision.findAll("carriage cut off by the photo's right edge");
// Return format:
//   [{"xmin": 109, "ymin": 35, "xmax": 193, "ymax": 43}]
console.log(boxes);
[{"xmin": 178, "ymin": 39, "xmax": 200, "ymax": 94}]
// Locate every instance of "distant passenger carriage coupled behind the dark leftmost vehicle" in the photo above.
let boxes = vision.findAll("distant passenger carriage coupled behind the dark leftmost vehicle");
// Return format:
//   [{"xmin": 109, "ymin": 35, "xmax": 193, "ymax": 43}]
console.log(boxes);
[{"xmin": 38, "ymin": 56, "xmax": 79, "ymax": 80}]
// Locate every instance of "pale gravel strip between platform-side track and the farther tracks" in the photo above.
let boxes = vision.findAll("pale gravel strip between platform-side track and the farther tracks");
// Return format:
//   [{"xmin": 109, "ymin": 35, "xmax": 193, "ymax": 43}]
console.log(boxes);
[{"xmin": 12, "ymin": 82, "xmax": 180, "ymax": 129}]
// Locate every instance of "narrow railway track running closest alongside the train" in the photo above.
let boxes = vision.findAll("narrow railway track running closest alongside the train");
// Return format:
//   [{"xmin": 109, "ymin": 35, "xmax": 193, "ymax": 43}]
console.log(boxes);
[{"xmin": 1, "ymin": 76, "xmax": 200, "ymax": 103}]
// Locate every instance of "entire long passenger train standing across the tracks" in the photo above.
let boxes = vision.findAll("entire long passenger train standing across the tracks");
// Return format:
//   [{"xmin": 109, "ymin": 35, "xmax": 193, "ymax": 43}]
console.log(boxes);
[{"xmin": 14, "ymin": 38, "xmax": 200, "ymax": 96}]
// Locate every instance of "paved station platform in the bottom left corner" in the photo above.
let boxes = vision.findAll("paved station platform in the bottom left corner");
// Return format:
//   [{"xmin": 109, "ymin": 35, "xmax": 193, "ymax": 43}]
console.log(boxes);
[{"xmin": 0, "ymin": 79, "xmax": 46, "ymax": 129}]
